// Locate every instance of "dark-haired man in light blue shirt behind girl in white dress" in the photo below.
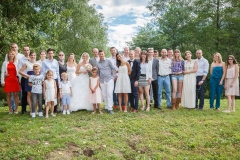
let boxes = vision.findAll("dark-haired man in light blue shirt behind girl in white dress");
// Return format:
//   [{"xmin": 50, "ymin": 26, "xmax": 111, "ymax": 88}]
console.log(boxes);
[{"xmin": 41, "ymin": 48, "xmax": 60, "ymax": 113}]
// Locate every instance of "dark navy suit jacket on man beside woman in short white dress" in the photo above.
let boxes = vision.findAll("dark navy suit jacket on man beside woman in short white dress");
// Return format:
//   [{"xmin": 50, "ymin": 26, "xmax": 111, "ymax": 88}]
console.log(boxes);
[{"xmin": 128, "ymin": 59, "xmax": 141, "ymax": 81}]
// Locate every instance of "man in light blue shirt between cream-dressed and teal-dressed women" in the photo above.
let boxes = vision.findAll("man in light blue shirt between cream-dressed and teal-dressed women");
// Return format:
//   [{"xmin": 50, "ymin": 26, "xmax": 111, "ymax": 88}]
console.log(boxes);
[{"xmin": 196, "ymin": 49, "xmax": 209, "ymax": 110}]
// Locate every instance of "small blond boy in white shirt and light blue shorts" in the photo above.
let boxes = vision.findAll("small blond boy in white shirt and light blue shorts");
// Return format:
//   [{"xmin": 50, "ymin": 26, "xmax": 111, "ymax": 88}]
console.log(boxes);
[{"xmin": 59, "ymin": 72, "xmax": 72, "ymax": 114}]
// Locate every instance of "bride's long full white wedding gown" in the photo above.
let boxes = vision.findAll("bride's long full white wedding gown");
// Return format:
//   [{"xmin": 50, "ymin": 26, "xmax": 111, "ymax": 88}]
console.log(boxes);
[{"xmin": 70, "ymin": 66, "xmax": 93, "ymax": 111}]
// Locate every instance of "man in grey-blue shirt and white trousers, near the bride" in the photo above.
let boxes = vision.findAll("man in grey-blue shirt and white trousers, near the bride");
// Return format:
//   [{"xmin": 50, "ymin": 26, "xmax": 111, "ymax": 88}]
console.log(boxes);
[{"xmin": 97, "ymin": 50, "xmax": 116, "ymax": 114}]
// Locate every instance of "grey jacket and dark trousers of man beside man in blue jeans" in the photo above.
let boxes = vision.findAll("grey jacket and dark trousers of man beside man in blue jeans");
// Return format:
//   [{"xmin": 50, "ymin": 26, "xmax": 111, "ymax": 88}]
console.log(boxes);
[{"xmin": 151, "ymin": 58, "xmax": 160, "ymax": 109}]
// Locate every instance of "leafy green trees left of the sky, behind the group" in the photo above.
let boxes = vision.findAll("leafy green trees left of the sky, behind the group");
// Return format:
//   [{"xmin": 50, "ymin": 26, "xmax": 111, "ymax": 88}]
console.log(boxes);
[{"xmin": 0, "ymin": 0, "xmax": 107, "ymax": 59}]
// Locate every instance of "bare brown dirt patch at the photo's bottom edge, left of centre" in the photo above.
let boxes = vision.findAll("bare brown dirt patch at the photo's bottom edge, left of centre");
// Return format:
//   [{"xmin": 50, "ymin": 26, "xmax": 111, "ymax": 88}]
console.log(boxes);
[{"xmin": 46, "ymin": 142, "xmax": 80, "ymax": 160}]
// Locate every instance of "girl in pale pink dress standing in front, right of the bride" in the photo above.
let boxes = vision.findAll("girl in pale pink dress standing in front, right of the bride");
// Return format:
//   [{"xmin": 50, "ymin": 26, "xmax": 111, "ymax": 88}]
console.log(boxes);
[{"xmin": 88, "ymin": 67, "xmax": 102, "ymax": 114}]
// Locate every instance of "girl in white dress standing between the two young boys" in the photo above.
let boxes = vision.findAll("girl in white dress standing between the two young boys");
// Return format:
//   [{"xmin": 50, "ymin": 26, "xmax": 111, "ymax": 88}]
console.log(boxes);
[{"xmin": 43, "ymin": 70, "xmax": 57, "ymax": 118}]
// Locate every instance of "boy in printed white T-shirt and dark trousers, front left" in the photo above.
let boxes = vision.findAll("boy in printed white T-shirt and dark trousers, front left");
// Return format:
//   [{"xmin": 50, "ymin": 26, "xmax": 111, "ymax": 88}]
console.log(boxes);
[{"xmin": 28, "ymin": 64, "xmax": 44, "ymax": 118}]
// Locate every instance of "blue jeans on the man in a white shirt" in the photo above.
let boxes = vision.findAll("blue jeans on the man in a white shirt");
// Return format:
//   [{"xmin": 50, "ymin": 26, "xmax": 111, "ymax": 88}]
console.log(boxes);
[{"xmin": 158, "ymin": 76, "xmax": 172, "ymax": 107}]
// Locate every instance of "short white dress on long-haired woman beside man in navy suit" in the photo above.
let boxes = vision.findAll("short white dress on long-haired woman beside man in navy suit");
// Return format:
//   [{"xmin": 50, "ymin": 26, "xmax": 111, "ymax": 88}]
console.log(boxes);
[{"xmin": 114, "ymin": 64, "xmax": 131, "ymax": 93}]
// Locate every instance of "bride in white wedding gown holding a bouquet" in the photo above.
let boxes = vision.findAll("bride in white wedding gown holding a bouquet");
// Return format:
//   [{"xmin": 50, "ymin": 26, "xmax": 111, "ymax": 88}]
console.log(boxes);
[{"xmin": 70, "ymin": 52, "xmax": 93, "ymax": 111}]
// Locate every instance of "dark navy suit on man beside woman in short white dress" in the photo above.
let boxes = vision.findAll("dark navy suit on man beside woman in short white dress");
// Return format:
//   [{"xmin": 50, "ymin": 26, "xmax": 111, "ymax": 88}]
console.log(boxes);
[{"xmin": 128, "ymin": 59, "xmax": 141, "ymax": 110}]
